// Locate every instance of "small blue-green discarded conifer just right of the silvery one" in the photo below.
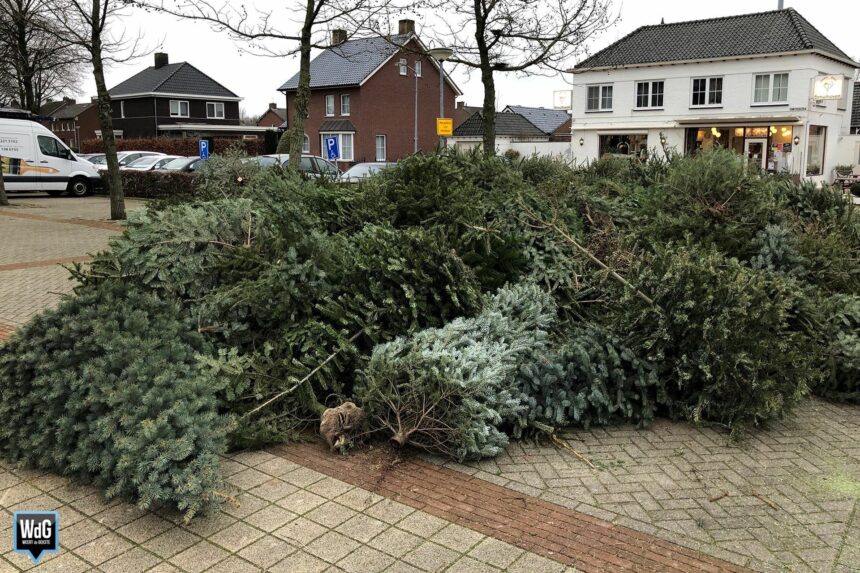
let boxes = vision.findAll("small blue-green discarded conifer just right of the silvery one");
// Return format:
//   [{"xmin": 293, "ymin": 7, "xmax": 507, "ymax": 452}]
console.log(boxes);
[{"xmin": 514, "ymin": 325, "xmax": 657, "ymax": 437}]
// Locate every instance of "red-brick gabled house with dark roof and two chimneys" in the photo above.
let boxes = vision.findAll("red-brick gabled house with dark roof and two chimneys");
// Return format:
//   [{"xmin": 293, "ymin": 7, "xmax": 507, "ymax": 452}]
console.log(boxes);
[{"xmin": 278, "ymin": 20, "xmax": 462, "ymax": 168}]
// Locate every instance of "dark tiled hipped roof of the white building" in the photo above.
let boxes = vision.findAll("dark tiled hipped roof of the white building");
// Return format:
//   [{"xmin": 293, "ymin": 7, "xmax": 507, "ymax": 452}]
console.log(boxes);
[{"xmin": 574, "ymin": 8, "xmax": 851, "ymax": 70}]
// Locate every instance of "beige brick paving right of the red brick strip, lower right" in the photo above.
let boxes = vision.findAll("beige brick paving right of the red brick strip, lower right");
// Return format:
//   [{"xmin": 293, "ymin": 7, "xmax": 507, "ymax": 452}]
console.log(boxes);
[{"xmin": 431, "ymin": 399, "xmax": 860, "ymax": 573}]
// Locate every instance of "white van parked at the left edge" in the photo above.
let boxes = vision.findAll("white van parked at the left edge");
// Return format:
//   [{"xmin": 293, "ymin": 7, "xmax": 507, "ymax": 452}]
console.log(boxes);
[{"xmin": 0, "ymin": 118, "xmax": 101, "ymax": 197}]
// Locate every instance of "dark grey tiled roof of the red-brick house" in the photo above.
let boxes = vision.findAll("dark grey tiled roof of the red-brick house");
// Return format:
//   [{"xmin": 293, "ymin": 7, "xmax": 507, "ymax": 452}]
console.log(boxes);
[{"xmin": 278, "ymin": 34, "xmax": 412, "ymax": 91}]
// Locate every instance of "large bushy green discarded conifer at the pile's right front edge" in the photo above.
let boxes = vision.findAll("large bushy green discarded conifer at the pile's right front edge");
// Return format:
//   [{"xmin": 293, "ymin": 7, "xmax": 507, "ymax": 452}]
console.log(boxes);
[{"xmin": 618, "ymin": 243, "xmax": 818, "ymax": 431}]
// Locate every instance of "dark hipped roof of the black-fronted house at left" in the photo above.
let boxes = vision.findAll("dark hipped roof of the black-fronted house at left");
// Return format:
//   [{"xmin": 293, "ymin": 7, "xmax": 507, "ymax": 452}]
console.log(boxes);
[{"xmin": 109, "ymin": 62, "xmax": 239, "ymax": 98}]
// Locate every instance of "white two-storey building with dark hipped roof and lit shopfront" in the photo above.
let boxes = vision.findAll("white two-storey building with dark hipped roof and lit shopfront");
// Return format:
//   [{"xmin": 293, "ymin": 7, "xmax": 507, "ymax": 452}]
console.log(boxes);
[{"xmin": 571, "ymin": 8, "xmax": 858, "ymax": 181}]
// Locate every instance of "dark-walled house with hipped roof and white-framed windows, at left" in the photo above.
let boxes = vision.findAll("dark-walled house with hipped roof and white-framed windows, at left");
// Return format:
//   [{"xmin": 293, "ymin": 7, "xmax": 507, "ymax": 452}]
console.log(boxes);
[{"xmin": 110, "ymin": 52, "xmax": 266, "ymax": 139}]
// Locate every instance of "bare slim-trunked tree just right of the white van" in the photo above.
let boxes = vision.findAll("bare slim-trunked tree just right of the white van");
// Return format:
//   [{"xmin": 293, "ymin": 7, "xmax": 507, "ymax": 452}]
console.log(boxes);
[{"xmin": 51, "ymin": 0, "xmax": 139, "ymax": 219}]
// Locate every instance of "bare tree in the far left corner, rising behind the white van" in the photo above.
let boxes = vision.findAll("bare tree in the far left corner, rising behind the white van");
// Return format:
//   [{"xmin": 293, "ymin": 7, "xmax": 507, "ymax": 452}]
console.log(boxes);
[{"xmin": 0, "ymin": 0, "xmax": 83, "ymax": 113}]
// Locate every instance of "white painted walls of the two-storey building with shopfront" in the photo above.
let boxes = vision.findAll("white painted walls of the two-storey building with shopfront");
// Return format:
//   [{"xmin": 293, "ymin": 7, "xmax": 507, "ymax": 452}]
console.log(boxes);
[{"xmin": 572, "ymin": 54, "xmax": 854, "ymax": 180}]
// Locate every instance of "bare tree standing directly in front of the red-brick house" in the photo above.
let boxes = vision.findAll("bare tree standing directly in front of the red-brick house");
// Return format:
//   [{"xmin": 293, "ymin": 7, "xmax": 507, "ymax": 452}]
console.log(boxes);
[{"xmin": 134, "ymin": 0, "xmax": 393, "ymax": 170}]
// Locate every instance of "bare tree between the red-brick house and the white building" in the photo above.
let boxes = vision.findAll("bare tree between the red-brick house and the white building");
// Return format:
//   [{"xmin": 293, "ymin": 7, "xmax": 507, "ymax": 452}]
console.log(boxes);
[{"xmin": 419, "ymin": 0, "xmax": 615, "ymax": 155}]
